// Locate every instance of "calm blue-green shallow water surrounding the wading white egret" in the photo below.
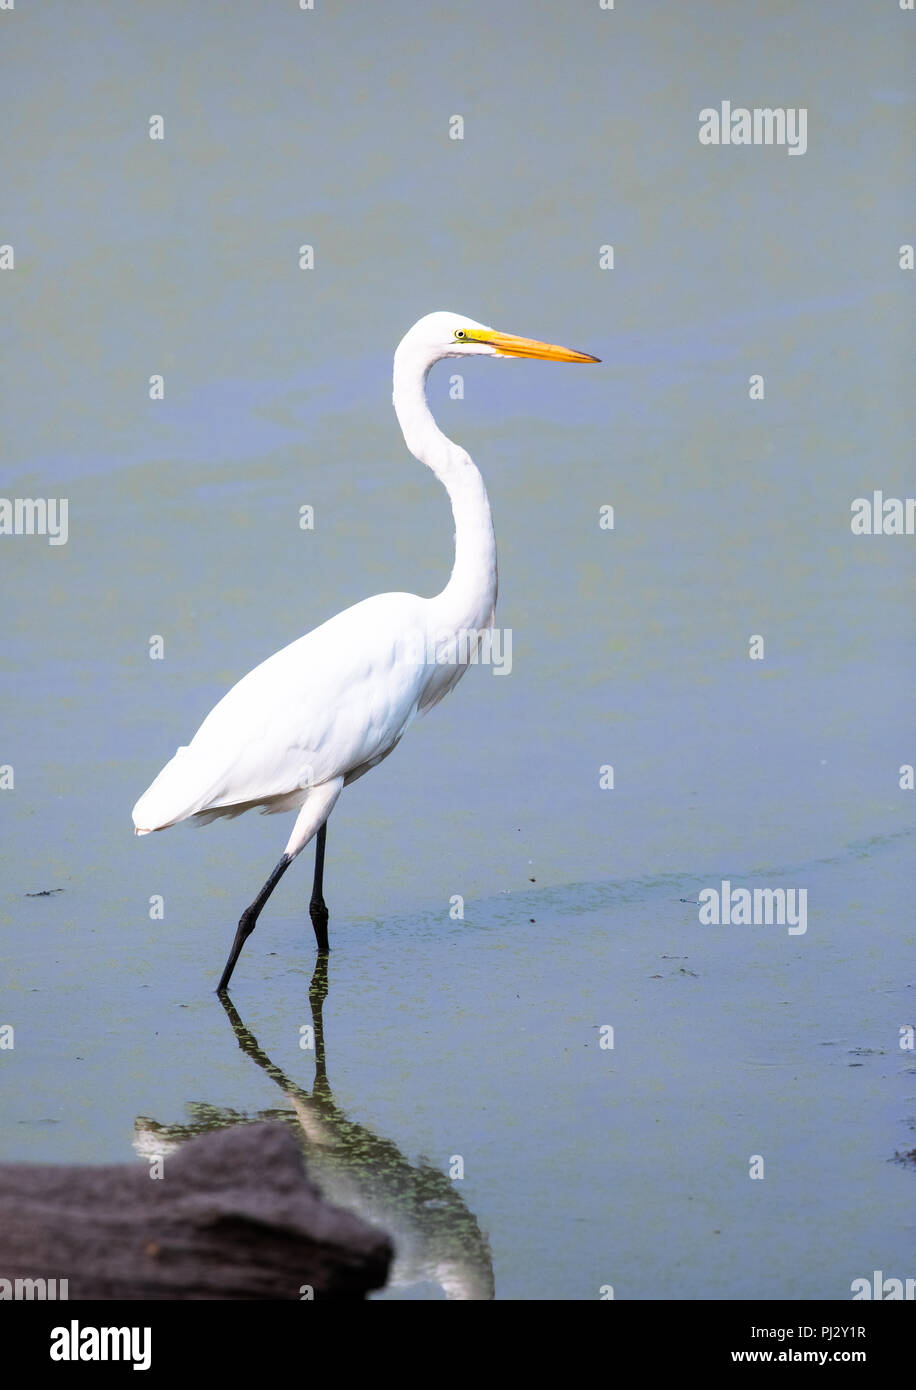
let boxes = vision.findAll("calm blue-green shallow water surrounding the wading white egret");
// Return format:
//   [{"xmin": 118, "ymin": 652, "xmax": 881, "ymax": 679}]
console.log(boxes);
[{"xmin": 0, "ymin": 3, "xmax": 916, "ymax": 1298}]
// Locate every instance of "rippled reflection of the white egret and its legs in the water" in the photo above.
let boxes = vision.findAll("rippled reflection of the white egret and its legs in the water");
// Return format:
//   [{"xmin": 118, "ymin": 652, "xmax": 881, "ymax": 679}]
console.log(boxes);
[{"xmin": 133, "ymin": 954, "xmax": 493, "ymax": 1298}]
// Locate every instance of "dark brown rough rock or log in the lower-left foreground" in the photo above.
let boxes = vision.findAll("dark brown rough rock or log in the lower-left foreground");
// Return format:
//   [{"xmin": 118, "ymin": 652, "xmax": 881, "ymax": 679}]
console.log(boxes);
[{"xmin": 0, "ymin": 1125, "xmax": 392, "ymax": 1300}]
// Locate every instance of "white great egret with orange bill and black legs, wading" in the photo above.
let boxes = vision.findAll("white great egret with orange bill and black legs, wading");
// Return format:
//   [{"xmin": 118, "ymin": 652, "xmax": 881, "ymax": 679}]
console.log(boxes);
[{"xmin": 133, "ymin": 313, "xmax": 599, "ymax": 992}]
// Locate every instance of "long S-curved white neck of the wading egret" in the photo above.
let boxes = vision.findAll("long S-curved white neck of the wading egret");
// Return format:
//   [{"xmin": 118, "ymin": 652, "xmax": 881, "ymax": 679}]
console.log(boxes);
[{"xmin": 393, "ymin": 349, "xmax": 496, "ymax": 631}]
